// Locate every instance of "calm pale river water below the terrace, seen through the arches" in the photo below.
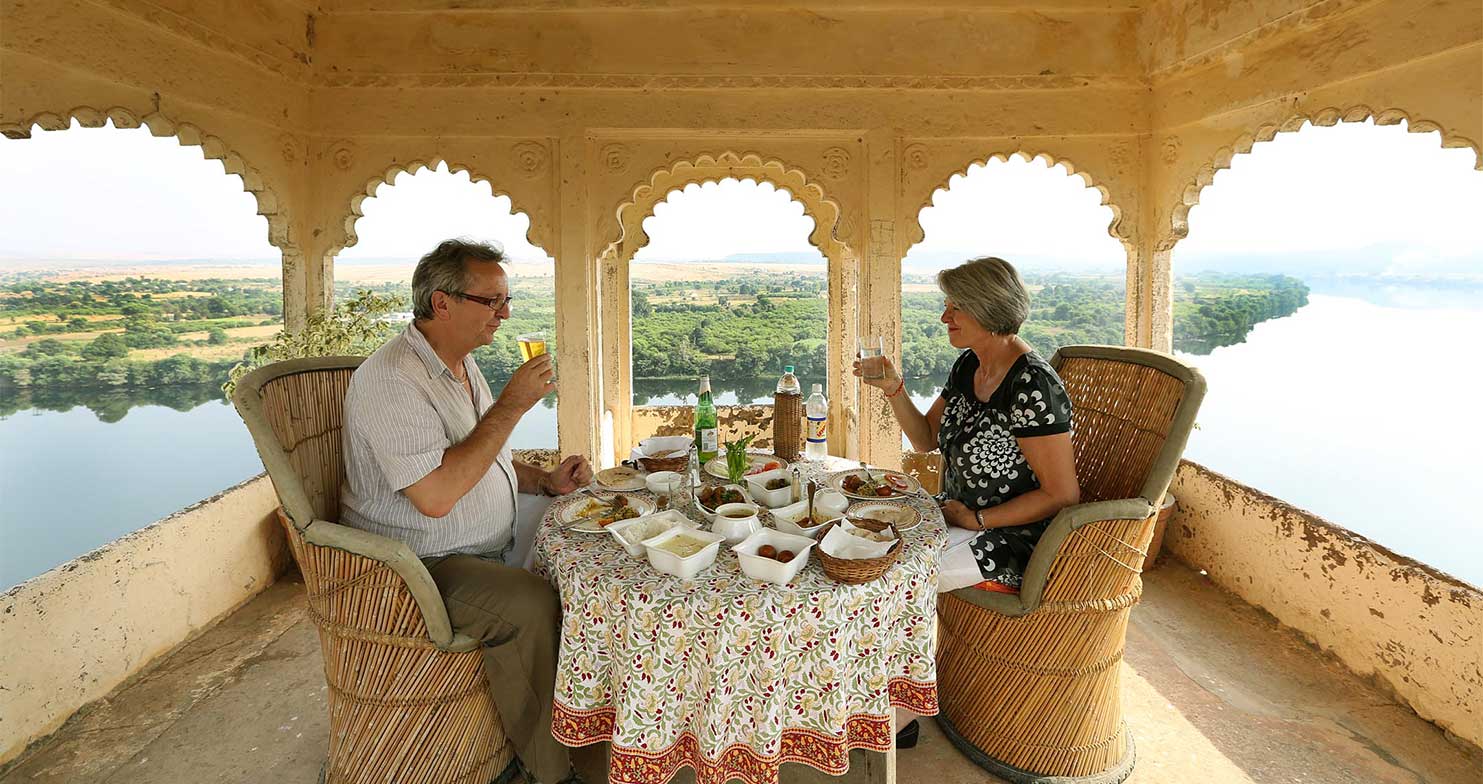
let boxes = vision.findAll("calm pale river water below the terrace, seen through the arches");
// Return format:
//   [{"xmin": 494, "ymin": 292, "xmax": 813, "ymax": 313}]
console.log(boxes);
[{"xmin": 0, "ymin": 292, "xmax": 1483, "ymax": 587}]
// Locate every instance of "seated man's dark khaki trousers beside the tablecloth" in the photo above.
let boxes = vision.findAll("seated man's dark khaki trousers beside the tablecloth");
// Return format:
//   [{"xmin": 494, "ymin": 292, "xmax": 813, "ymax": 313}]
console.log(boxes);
[{"xmin": 423, "ymin": 556, "xmax": 571, "ymax": 784}]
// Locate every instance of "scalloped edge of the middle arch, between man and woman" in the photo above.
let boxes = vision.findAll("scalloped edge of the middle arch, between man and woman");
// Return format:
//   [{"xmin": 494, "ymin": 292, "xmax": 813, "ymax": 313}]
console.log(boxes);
[{"xmin": 599, "ymin": 151, "xmax": 850, "ymax": 261}]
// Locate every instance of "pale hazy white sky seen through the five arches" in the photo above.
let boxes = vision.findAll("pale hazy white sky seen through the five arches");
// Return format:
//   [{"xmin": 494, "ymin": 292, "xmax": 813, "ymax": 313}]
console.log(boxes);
[{"xmin": 0, "ymin": 123, "xmax": 1483, "ymax": 270}]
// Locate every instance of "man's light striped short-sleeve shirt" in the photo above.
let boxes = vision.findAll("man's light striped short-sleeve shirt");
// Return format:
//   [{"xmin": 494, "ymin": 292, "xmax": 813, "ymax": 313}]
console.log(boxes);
[{"xmin": 340, "ymin": 323, "xmax": 516, "ymax": 557}]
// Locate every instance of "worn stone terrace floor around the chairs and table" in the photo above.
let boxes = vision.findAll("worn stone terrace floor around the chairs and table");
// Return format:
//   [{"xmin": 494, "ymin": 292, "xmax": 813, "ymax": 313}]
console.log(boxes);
[{"xmin": 0, "ymin": 563, "xmax": 1483, "ymax": 784}]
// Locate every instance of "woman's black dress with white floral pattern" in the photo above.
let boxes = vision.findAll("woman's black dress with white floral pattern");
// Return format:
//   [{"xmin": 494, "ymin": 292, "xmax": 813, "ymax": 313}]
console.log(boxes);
[{"xmin": 937, "ymin": 350, "xmax": 1071, "ymax": 588}]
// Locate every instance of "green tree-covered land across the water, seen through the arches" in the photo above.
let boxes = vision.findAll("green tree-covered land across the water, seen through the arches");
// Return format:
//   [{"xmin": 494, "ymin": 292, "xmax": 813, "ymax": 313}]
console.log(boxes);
[{"xmin": 0, "ymin": 273, "xmax": 1308, "ymax": 403}]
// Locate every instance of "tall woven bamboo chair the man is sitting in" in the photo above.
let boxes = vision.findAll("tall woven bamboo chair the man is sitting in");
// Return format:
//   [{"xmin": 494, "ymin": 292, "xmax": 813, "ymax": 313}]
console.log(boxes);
[{"xmin": 233, "ymin": 357, "xmax": 515, "ymax": 784}]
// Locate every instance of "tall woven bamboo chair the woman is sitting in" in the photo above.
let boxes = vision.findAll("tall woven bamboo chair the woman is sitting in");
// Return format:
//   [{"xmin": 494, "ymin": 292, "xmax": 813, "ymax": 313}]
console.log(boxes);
[{"xmin": 937, "ymin": 345, "xmax": 1206, "ymax": 784}]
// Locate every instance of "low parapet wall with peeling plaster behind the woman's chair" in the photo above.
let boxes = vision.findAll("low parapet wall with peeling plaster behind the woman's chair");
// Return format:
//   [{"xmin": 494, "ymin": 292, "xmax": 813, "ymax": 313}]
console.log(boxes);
[{"xmin": 1164, "ymin": 461, "xmax": 1483, "ymax": 745}]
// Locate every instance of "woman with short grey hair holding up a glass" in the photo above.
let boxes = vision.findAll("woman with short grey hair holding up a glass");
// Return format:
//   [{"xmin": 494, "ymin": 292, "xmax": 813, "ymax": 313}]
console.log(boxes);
[{"xmin": 854, "ymin": 258, "xmax": 1081, "ymax": 593}]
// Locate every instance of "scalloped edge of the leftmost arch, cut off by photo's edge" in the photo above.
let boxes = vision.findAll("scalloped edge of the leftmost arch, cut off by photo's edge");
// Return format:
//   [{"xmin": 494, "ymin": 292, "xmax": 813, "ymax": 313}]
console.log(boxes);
[{"xmin": 0, "ymin": 107, "xmax": 294, "ymax": 252}]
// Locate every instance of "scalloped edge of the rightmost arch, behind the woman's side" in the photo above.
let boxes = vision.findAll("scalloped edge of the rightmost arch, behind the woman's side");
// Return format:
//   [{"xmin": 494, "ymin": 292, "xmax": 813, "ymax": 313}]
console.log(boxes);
[{"xmin": 1158, "ymin": 104, "xmax": 1483, "ymax": 250}]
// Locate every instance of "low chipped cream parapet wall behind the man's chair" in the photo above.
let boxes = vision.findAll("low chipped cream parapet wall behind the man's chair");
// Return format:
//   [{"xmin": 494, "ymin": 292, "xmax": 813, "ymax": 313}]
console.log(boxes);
[{"xmin": 0, "ymin": 476, "xmax": 289, "ymax": 765}]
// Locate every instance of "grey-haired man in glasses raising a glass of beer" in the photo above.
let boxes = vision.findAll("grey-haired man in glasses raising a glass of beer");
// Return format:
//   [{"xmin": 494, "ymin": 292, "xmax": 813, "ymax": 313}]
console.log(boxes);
[{"xmin": 341, "ymin": 240, "xmax": 592, "ymax": 784}]
